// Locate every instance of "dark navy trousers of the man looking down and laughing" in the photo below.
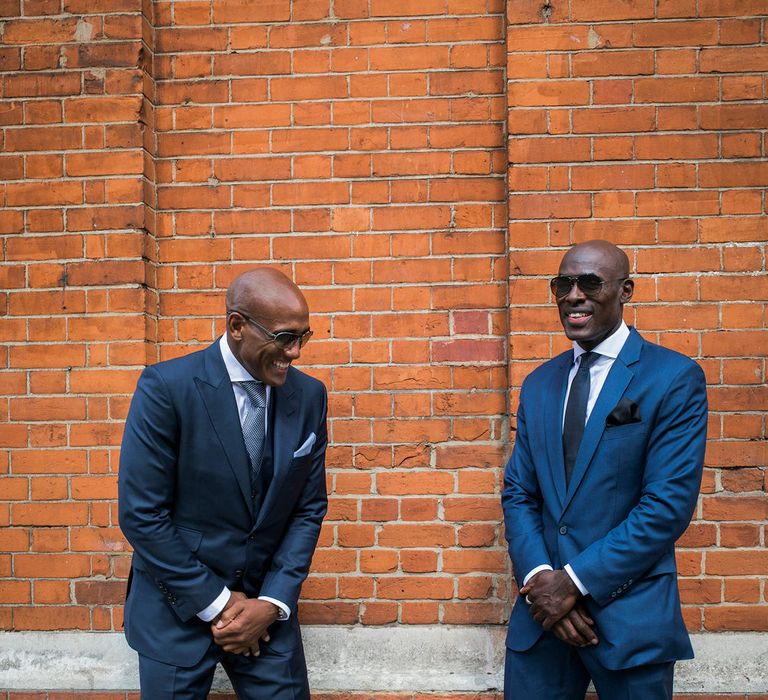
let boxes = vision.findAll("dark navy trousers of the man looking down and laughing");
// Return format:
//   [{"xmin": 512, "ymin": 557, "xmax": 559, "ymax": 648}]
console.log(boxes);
[{"xmin": 139, "ymin": 641, "xmax": 309, "ymax": 700}]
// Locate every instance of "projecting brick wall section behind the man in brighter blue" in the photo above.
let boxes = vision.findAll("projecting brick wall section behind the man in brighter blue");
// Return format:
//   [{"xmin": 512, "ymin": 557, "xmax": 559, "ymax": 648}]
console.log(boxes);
[{"xmin": 507, "ymin": 0, "xmax": 768, "ymax": 631}]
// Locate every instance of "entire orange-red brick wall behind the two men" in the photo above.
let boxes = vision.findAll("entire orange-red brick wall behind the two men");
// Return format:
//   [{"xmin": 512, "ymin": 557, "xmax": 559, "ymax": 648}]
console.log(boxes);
[{"xmin": 0, "ymin": 0, "xmax": 768, "ymax": 652}]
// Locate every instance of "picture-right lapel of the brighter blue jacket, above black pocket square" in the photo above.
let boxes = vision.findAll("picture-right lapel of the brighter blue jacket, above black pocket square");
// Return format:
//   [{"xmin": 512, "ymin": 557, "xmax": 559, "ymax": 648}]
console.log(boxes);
[{"xmin": 563, "ymin": 328, "xmax": 643, "ymax": 508}]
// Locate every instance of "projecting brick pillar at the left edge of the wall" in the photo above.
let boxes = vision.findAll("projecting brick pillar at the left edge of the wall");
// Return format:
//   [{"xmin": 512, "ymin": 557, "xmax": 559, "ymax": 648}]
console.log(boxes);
[{"xmin": 0, "ymin": 0, "xmax": 150, "ymax": 630}]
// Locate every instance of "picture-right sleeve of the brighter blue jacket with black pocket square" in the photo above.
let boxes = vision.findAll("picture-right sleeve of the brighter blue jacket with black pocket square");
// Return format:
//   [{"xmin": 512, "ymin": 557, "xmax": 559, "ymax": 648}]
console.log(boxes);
[{"xmin": 569, "ymin": 362, "xmax": 707, "ymax": 605}]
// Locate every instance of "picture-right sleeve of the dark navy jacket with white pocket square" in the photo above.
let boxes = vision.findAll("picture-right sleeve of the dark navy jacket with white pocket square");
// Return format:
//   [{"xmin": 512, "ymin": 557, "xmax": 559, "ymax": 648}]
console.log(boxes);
[{"xmin": 259, "ymin": 385, "xmax": 328, "ymax": 609}]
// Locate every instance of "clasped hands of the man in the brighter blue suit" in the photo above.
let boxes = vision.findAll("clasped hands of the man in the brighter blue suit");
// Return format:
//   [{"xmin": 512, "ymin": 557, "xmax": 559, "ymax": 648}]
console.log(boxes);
[{"xmin": 520, "ymin": 569, "xmax": 597, "ymax": 647}]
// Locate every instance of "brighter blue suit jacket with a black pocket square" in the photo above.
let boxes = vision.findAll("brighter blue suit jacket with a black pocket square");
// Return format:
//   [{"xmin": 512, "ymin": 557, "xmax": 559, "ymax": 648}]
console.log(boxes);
[{"xmin": 502, "ymin": 329, "xmax": 707, "ymax": 670}]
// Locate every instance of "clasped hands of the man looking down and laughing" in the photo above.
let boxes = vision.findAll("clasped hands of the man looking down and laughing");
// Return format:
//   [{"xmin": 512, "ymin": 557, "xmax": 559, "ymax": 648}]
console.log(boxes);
[{"xmin": 211, "ymin": 591, "xmax": 277, "ymax": 656}]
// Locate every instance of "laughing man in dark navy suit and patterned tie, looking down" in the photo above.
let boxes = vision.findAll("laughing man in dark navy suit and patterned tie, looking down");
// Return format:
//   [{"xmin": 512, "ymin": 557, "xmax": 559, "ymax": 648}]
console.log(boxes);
[{"xmin": 119, "ymin": 268, "xmax": 327, "ymax": 700}]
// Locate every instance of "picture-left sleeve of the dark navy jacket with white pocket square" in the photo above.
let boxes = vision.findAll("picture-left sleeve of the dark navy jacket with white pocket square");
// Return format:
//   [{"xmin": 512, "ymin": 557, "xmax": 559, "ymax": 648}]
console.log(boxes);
[{"xmin": 118, "ymin": 367, "xmax": 225, "ymax": 620}]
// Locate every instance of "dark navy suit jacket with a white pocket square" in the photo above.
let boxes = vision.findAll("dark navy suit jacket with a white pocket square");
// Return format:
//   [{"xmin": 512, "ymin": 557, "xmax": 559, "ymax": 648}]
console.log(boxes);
[{"xmin": 119, "ymin": 342, "xmax": 327, "ymax": 666}]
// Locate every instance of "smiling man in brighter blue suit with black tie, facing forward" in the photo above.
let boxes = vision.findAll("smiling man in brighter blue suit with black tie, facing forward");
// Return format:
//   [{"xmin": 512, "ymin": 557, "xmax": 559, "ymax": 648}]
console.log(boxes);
[{"xmin": 502, "ymin": 241, "xmax": 707, "ymax": 700}]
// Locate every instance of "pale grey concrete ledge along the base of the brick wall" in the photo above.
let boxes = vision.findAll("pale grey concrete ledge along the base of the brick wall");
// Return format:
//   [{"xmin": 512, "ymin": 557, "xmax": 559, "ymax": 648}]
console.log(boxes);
[{"xmin": 0, "ymin": 625, "xmax": 768, "ymax": 694}]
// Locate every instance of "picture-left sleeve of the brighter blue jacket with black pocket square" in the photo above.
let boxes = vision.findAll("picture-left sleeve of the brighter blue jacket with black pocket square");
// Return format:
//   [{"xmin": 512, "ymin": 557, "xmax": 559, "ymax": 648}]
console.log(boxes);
[{"xmin": 501, "ymin": 384, "xmax": 552, "ymax": 586}]
